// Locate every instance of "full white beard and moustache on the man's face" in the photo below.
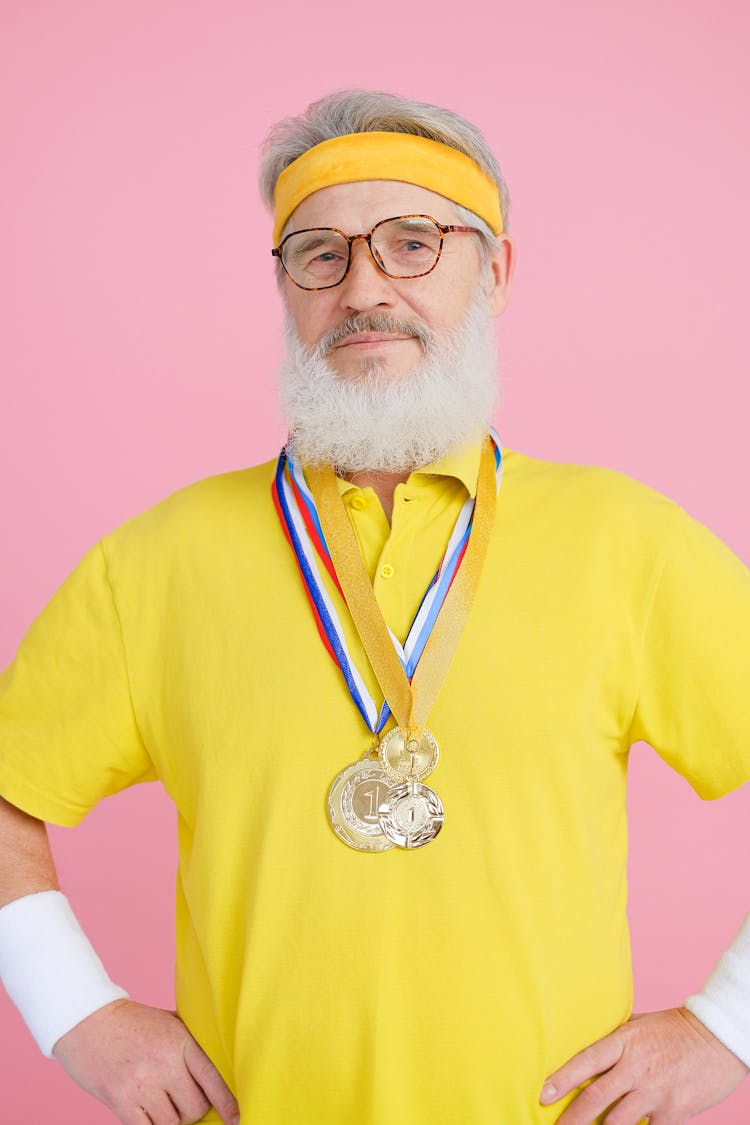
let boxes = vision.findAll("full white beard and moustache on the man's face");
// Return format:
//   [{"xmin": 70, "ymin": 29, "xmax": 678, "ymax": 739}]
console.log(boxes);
[{"xmin": 279, "ymin": 286, "xmax": 497, "ymax": 473}]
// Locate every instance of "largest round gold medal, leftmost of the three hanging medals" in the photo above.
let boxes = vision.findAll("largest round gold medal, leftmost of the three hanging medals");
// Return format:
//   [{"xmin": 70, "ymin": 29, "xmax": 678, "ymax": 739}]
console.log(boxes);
[{"xmin": 327, "ymin": 759, "xmax": 394, "ymax": 852}]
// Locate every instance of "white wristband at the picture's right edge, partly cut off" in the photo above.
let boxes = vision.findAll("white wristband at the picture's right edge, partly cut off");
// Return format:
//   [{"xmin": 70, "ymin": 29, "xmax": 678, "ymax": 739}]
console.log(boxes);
[{"xmin": 685, "ymin": 915, "xmax": 750, "ymax": 1067}]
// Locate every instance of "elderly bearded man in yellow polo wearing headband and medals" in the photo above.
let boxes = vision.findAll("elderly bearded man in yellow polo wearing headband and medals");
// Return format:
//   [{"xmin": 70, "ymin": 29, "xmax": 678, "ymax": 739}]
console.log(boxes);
[{"xmin": 0, "ymin": 92, "xmax": 750, "ymax": 1125}]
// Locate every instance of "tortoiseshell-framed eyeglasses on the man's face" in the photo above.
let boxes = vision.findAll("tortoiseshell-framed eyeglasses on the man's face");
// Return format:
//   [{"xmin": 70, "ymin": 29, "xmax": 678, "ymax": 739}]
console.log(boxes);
[{"xmin": 271, "ymin": 215, "xmax": 481, "ymax": 289}]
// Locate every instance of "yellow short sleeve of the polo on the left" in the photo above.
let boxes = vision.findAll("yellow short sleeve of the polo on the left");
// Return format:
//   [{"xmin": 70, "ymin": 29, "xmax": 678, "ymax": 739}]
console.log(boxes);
[{"xmin": 0, "ymin": 543, "xmax": 155, "ymax": 825}]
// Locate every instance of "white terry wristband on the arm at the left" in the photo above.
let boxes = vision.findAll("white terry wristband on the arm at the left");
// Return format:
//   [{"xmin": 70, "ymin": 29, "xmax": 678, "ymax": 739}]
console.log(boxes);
[{"xmin": 0, "ymin": 891, "xmax": 127, "ymax": 1058}]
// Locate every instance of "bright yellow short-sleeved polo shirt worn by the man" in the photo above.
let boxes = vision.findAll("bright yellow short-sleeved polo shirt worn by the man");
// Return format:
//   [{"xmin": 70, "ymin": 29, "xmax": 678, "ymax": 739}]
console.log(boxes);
[{"xmin": 0, "ymin": 451, "xmax": 750, "ymax": 1125}]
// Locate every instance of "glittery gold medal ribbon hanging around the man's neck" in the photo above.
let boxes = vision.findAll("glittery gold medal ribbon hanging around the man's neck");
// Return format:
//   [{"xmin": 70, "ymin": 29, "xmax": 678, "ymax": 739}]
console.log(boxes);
[{"xmin": 300, "ymin": 438, "xmax": 501, "ymax": 740}]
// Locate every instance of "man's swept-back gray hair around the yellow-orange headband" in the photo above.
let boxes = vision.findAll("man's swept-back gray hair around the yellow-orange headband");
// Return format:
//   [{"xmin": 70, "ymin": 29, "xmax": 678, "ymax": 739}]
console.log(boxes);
[{"xmin": 259, "ymin": 90, "xmax": 510, "ymax": 261}]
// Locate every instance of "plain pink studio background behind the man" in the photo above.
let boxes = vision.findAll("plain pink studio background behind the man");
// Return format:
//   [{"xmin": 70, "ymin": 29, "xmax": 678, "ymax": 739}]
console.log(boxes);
[{"xmin": 0, "ymin": 0, "xmax": 750, "ymax": 1125}]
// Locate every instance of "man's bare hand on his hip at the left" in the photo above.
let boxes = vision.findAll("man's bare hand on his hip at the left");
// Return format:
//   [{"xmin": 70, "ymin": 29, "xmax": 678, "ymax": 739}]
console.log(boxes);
[{"xmin": 53, "ymin": 1000, "xmax": 240, "ymax": 1125}]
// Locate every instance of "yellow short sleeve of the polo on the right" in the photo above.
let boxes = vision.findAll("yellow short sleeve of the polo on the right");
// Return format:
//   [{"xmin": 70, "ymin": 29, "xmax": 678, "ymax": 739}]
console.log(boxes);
[{"xmin": 631, "ymin": 505, "xmax": 750, "ymax": 798}]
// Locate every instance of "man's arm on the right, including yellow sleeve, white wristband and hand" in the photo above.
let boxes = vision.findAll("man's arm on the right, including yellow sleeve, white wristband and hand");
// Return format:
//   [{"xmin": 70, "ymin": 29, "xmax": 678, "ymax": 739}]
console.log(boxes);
[{"xmin": 540, "ymin": 509, "xmax": 750, "ymax": 1125}]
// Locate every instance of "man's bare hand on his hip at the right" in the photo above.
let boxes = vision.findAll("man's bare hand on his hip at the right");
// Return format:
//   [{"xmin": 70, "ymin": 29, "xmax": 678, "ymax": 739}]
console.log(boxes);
[{"xmin": 540, "ymin": 1008, "xmax": 749, "ymax": 1125}]
